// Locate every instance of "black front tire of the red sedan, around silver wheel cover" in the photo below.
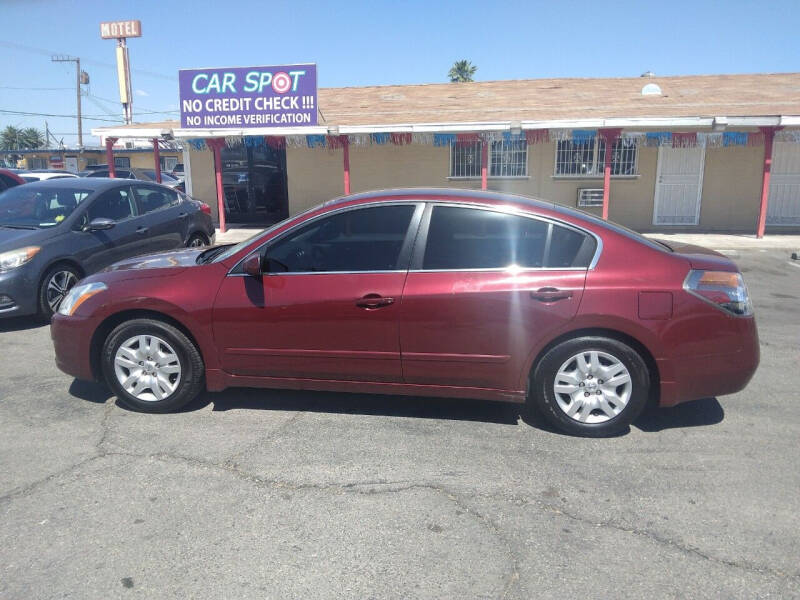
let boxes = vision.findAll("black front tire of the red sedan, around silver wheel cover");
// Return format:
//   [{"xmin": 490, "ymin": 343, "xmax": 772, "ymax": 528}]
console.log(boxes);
[{"xmin": 101, "ymin": 319, "xmax": 205, "ymax": 413}]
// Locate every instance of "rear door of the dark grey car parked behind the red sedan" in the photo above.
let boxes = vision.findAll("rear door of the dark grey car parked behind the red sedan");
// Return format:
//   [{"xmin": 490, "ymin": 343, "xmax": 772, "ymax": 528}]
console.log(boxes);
[{"xmin": 131, "ymin": 183, "xmax": 189, "ymax": 252}]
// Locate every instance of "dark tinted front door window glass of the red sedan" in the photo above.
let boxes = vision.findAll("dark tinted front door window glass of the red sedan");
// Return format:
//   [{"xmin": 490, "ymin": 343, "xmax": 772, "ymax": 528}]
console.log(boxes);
[{"xmin": 266, "ymin": 204, "xmax": 416, "ymax": 273}]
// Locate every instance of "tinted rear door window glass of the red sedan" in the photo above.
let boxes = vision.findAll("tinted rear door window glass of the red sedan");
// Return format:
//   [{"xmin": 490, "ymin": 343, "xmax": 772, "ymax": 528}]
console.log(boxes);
[{"xmin": 421, "ymin": 206, "xmax": 595, "ymax": 270}]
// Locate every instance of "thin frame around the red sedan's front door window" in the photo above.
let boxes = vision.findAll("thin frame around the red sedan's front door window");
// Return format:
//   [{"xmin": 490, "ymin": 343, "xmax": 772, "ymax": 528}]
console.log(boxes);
[{"xmin": 226, "ymin": 199, "xmax": 426, "ymax": 277}]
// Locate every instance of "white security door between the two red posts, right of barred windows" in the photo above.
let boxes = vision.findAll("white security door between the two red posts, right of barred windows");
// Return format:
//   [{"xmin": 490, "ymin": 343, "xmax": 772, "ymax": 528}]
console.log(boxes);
[{"xmin": 653, "ymin": 146, "xmax": 706, "ymax": 225}]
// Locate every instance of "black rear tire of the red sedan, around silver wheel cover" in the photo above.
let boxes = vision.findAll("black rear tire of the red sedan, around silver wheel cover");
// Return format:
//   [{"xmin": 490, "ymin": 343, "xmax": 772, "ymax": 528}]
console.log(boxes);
[{"xmin": 528, "ymin": 336, "xmax": 650, "ymax": 437}]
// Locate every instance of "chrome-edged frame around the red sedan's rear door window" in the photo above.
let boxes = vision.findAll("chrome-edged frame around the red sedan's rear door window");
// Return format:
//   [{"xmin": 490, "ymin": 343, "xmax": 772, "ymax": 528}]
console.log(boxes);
[{"xmin": 408, "ymin": 201, "xmax": 603, "ymax": 273}]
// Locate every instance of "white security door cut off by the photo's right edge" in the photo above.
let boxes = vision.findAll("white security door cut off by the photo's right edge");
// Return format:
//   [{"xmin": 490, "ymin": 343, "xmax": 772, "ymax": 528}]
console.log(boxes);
[{"xmin": 767, "ymin": 142, "xmax": 800, "ymax": 225}]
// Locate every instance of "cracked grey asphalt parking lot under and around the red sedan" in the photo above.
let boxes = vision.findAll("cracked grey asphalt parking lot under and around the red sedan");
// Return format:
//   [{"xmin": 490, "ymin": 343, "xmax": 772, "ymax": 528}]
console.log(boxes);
[{"xmin": 0, "ymin": 250, "xmax": 800, "ymax": 599}]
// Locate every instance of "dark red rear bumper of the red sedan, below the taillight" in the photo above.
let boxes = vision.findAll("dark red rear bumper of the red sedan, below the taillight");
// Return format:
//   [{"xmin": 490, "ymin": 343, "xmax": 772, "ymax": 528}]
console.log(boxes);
[{"xmin": 657, "ymin": 317, "xmax": 760, "ymax": 406}]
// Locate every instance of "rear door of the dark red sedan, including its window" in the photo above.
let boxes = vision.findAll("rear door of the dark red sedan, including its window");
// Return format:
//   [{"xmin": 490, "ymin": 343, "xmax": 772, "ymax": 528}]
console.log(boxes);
[{"xmin": 400, "ymin": 205, "xmax": 596, "ymax": 391}]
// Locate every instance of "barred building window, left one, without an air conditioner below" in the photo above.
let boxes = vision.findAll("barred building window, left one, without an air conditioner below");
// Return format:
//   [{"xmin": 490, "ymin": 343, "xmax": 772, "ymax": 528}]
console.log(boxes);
[{"xmin": 450, "ymin": 140, "xmax": 528, "ymax": 178}]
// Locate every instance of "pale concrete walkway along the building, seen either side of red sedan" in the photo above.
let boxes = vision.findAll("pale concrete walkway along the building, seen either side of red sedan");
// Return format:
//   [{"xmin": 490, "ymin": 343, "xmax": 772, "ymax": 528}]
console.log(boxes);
[{"xmin": 217, "ymin": 228, "xmax": 800, "ymax": 252}]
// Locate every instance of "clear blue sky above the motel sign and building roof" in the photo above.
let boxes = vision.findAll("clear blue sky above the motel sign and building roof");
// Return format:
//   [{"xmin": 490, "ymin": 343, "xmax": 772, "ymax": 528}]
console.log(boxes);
[{"xmin": 0, "ymin": 0, "xmax": 800, "ymax": 144}]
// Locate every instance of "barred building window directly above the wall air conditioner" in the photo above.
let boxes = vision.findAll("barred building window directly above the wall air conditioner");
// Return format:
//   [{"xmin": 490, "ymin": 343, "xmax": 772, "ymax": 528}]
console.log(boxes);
[{"xmin": 554, "ymin": 137, "xmax": 638, "ymax": 177}]
